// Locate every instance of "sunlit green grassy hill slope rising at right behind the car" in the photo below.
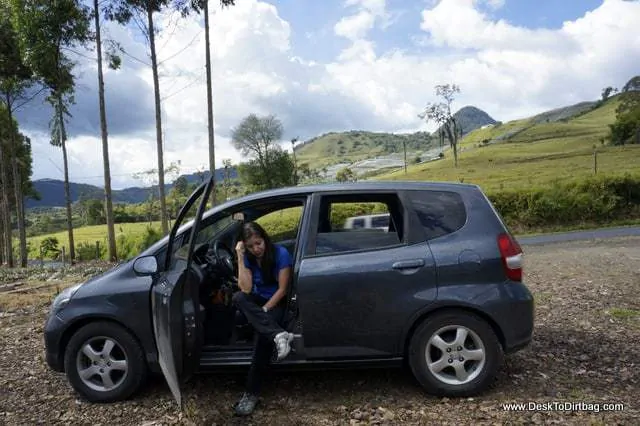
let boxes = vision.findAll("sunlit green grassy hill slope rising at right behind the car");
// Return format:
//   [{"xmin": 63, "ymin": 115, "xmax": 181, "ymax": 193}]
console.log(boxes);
[{"xmin": 376, "ymin": 98, "xmax": 640, "ymax": 190}]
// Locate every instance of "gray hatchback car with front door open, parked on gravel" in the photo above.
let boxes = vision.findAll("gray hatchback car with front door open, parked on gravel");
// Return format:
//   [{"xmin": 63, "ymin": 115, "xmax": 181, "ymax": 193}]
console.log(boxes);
[{"xmin": 44, "ymin": 180, "xmax": 534, "ymax": 404}]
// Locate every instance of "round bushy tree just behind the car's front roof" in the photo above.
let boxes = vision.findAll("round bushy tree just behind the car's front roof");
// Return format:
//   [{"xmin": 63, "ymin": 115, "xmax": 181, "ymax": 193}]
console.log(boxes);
[{"xmin": 231, "ymin": 114, "xmax": 294, "ymax": 190}]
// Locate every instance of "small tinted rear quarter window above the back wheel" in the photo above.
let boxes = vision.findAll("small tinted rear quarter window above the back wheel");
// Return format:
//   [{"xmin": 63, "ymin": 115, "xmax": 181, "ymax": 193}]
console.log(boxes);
[{"xmin": 407, "ymin": 191, "xmax": 467, "ymax": 240}]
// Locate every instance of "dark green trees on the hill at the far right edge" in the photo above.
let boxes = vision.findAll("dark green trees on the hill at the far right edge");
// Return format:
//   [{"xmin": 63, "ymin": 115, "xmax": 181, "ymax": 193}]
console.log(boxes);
[{"xmin": 609, "ymin": 75, "xmax": 640, "ymax": 145}]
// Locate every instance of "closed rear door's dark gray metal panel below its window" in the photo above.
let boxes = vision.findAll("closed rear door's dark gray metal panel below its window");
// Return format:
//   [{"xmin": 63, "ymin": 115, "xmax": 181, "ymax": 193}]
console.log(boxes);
[{"xmin": 297, "ymin": 244, "xmax": 437, "ymax": 358}]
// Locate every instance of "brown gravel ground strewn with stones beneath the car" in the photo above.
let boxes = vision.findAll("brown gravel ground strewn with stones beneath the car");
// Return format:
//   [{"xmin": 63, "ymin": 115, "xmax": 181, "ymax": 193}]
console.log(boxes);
[{"xmin": 0, "ymin": 237, "xmax": 640, "ymax": 425}]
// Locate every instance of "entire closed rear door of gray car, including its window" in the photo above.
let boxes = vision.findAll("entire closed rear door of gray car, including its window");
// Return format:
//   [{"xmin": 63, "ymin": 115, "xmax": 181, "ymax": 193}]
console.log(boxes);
[{"xmin": 296, "ymin": 191, "xmax": 437, "ymax": 359}]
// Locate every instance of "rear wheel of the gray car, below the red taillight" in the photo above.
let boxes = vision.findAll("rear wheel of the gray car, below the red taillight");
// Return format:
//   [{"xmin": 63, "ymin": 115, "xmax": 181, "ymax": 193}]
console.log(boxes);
[{"xmin": 408, "ymin": 311, "xmax": 503, "ymax": 397}]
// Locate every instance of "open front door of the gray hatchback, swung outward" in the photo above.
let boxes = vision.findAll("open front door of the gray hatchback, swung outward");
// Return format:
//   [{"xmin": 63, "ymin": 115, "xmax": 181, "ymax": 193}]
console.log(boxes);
[{"xmin": 151, "ymin": 177, "xmax": 213, "ymax": 407}]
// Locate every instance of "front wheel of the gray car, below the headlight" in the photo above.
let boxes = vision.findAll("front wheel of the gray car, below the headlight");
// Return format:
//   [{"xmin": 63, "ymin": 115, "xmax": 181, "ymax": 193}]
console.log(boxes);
[{"xmin": 64, "ymin": 322, "xmax": 147, "ymax": 402}]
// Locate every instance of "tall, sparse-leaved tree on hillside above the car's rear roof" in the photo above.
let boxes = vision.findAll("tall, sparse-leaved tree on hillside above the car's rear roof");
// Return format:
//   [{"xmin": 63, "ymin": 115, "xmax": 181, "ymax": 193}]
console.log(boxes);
[{"xmin": 418, "ymin": 84, "xmax": 461, "ymax": 167}]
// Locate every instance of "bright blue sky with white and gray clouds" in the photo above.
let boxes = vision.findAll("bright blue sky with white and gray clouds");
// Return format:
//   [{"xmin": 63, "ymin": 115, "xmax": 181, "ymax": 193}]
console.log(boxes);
[{"xmin": 12, "ymin": 0, "xmax": 640, "ymax": 189}]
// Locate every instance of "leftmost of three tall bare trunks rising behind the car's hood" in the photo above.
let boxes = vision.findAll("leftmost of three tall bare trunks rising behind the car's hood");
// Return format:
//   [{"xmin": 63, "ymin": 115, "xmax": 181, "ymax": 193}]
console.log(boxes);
[{"xmin": 93, "ymin": 0, "xmax": 118, "ymax": 262}]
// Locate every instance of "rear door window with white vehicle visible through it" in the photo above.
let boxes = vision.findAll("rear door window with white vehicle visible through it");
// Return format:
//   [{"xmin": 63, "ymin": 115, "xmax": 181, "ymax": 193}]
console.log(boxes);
[{"xmin": 314, "ymin": 194, "xmax": 405, "ymax": 255}]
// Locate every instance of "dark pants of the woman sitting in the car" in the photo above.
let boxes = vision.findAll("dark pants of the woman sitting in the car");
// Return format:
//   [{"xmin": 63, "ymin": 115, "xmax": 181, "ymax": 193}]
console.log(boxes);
[{"xmin": 233, "ymin": 291, "xmax": 284, "ymax": 395}]
